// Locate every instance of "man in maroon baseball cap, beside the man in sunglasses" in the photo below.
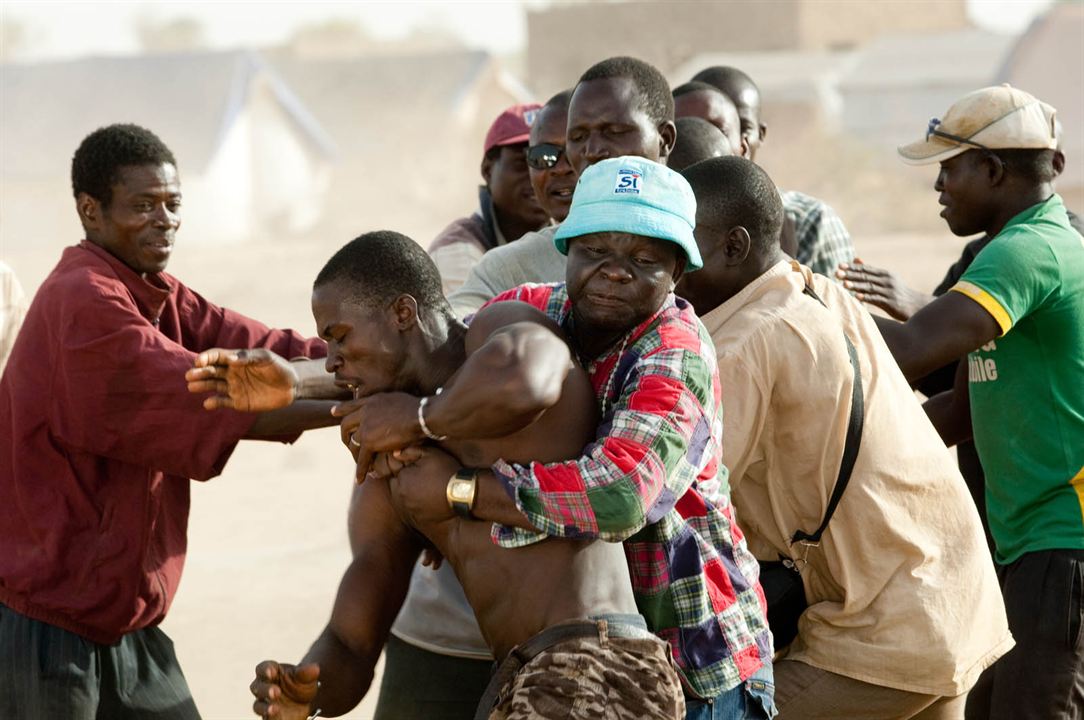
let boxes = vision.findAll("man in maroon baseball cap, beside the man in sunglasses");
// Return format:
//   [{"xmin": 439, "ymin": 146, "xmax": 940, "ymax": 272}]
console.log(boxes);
[{"xmin": 429, "ymin": 103, "xmax": 550, "ymax": 294}]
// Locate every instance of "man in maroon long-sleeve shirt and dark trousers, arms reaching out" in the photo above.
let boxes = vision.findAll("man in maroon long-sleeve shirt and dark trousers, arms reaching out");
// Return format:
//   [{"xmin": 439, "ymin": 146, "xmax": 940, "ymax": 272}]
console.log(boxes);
[{"xmin": 0, "ymin": 125, "xmax": 336, "ymax": 720}]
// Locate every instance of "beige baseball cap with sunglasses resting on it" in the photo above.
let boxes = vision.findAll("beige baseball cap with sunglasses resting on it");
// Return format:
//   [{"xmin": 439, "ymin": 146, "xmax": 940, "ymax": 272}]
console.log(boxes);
[{"xmin": 898, "ymin": 83, "xmax": 1058, "ymax": 165}]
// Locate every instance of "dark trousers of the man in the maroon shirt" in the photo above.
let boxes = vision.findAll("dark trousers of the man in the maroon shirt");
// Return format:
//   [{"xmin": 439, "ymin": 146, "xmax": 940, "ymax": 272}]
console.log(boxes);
[{"xmin": 0, "ymin": 605, "xmax": 199, "ymax": 720}]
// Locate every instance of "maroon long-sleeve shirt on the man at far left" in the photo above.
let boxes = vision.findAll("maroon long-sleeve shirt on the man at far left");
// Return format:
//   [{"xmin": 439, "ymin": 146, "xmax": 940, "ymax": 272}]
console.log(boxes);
[{"xmin": 0, "ymin": 241, "xmax": 326, "ymax": 644}]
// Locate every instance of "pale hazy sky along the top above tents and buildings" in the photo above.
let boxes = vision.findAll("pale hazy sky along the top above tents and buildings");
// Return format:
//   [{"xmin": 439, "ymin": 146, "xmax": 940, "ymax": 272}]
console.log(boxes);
[{"xmin": 0, "ymin": 0, "xmax": 1053, "ymax": 61}]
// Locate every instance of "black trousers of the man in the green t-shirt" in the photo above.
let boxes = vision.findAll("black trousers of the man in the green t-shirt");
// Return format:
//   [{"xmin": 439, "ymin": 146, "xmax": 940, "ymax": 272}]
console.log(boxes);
[{"xmin": 967, "ymin": 550, "xmax": 1084, "ymax": 720}]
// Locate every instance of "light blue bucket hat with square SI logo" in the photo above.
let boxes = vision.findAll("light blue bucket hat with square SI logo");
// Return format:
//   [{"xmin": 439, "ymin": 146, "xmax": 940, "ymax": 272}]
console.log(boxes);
[{"xmin": 553, "ymin": 156, "xmax": 704, "ymax": 270}]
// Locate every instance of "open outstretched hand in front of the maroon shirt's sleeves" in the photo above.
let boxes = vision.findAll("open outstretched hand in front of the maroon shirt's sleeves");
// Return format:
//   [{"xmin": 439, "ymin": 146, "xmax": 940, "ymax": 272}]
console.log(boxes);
[{"xmin": 184, "ymin": 348, "xmax": 298, "ymax": 412}]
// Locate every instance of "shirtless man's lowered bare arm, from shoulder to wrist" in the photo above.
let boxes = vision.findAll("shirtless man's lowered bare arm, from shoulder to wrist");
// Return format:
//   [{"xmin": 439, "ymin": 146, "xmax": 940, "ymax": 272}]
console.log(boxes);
[{"xmin": 302, "ymin": 480, "xmax": 422, "ymax": 716}]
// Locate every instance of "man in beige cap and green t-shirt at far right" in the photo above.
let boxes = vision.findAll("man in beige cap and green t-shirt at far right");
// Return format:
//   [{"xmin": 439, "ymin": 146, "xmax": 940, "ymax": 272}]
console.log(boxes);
[{"xmin": 878, "ymin": 85, "xmax": 1084, "ymax": 720}]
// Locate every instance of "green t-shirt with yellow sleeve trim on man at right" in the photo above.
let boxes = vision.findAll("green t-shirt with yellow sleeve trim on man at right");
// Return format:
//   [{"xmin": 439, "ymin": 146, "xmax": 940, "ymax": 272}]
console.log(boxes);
[{"xmin": 952, "ymin": 195, "xmax": 1084, "ymax": 564}]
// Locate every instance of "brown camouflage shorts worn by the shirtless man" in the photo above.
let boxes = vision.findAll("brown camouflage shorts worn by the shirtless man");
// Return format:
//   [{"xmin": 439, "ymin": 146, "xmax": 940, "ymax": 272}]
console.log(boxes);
[{"xmin": 489, "ymin": 620, "xmax": 685, "ymax": 720}]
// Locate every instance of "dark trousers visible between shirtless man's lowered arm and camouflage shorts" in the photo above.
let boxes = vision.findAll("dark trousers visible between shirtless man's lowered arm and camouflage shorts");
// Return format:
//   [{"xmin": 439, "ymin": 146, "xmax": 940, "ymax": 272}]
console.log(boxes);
[{"xmin": 373, "ymin": 635, "xmax": 493, "ymax": 720}]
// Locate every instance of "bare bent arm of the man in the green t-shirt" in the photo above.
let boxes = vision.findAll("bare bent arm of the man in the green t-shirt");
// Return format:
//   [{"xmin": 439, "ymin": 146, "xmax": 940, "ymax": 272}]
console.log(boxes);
[{"xmin": 874, "ymin": 292, "xmax": 1002, "ymax": 383}]
